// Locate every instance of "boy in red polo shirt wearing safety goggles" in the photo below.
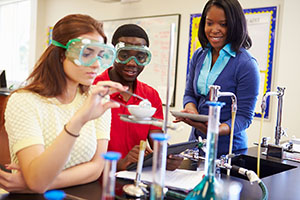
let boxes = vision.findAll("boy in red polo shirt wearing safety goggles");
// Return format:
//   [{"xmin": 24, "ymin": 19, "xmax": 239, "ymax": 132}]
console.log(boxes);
[{"xmin": 94, "ymin": 24, "xmax": 182, "ymax": 170}]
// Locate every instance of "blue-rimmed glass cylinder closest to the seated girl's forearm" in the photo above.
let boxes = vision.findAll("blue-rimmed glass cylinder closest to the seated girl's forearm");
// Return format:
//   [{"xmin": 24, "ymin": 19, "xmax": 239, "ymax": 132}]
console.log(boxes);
[{"xmin": 101, "ymin": 151, "xmax": 121, "ymax": 200}]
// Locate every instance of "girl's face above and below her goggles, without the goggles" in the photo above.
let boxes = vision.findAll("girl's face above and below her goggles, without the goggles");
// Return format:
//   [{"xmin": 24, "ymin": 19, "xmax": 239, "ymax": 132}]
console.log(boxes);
[{"xmin": 63, "ymin": 32, "xmax": 104, "ymax": 87}]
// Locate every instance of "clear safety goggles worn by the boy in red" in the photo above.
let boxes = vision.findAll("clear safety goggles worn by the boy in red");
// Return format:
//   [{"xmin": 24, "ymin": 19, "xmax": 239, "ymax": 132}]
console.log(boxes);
[{"xmin": 115, "ymin": 42, "xmax": 151, "ymax": 66}]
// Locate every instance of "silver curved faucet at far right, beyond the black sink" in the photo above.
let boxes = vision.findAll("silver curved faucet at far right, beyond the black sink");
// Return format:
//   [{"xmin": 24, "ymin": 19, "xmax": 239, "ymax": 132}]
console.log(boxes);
[{"xmin": 261, "ymin": 87, "xmax": 285, "ymax": 145}]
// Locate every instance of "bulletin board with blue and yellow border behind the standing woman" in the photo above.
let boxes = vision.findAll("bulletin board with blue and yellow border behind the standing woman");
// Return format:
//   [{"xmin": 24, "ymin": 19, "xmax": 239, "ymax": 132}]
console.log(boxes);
[{"xmin": 187, "ymin": 6, "xmax": 277, "ymax": 118}]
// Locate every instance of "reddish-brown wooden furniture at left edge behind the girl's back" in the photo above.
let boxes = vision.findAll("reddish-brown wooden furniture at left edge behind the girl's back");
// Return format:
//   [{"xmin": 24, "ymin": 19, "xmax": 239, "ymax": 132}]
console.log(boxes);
[{"xmin": 0, "ymin": 94, "xmax": 10, "ymax": 165}]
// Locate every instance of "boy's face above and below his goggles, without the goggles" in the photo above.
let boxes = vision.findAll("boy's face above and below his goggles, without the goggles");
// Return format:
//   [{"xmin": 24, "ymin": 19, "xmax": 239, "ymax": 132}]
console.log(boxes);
[{"xmin": 112, "ymin": 37, "xmax": 147, "ymax": 85}]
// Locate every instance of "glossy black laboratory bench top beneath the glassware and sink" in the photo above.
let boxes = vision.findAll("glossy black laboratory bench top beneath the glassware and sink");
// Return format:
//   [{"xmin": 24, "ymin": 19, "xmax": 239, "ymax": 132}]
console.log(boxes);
[{"xmin": 0, "ymin": 147, "xmax": 300, "ymax": 200}]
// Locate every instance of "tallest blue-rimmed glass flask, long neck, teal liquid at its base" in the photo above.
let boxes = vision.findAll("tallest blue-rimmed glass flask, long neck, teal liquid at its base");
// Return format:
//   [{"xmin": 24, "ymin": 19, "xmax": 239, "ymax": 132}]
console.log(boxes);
[{"xmin": 185, "ymin": 101, "xmax": 224, "ymax": 200}]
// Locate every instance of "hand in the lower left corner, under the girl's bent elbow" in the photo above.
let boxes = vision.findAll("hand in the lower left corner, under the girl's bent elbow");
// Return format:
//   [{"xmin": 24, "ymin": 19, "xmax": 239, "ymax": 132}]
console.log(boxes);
[{"xmin": 0, "ymin": 164, "xmax": 29, "ymax": 193}]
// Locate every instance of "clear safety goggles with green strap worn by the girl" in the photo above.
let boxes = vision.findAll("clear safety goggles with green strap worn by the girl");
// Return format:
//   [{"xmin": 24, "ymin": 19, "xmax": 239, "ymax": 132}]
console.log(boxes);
[{"xmin": 52, "ymin": 38, "xmax": 116, "ymax": 68}]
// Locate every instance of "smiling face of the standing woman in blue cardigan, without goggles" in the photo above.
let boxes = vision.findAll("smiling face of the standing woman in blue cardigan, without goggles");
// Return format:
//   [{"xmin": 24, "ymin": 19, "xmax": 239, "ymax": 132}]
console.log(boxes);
[{"xmin": 204, "ymin": 6, "xmax": 227, "ymax": 52}]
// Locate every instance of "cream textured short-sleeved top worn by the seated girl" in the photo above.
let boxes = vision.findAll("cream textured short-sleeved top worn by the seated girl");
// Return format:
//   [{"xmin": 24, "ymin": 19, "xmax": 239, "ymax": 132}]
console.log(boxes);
[{"xmin": 5, "ymin": 88, "xmax": 111, "ymax": 169}]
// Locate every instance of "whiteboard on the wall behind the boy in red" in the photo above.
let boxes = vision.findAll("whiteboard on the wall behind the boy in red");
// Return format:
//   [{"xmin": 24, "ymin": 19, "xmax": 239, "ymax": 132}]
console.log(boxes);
[{"xmin": 103, "ymin": 14, "xmax": 180, "ymax": 106}]
